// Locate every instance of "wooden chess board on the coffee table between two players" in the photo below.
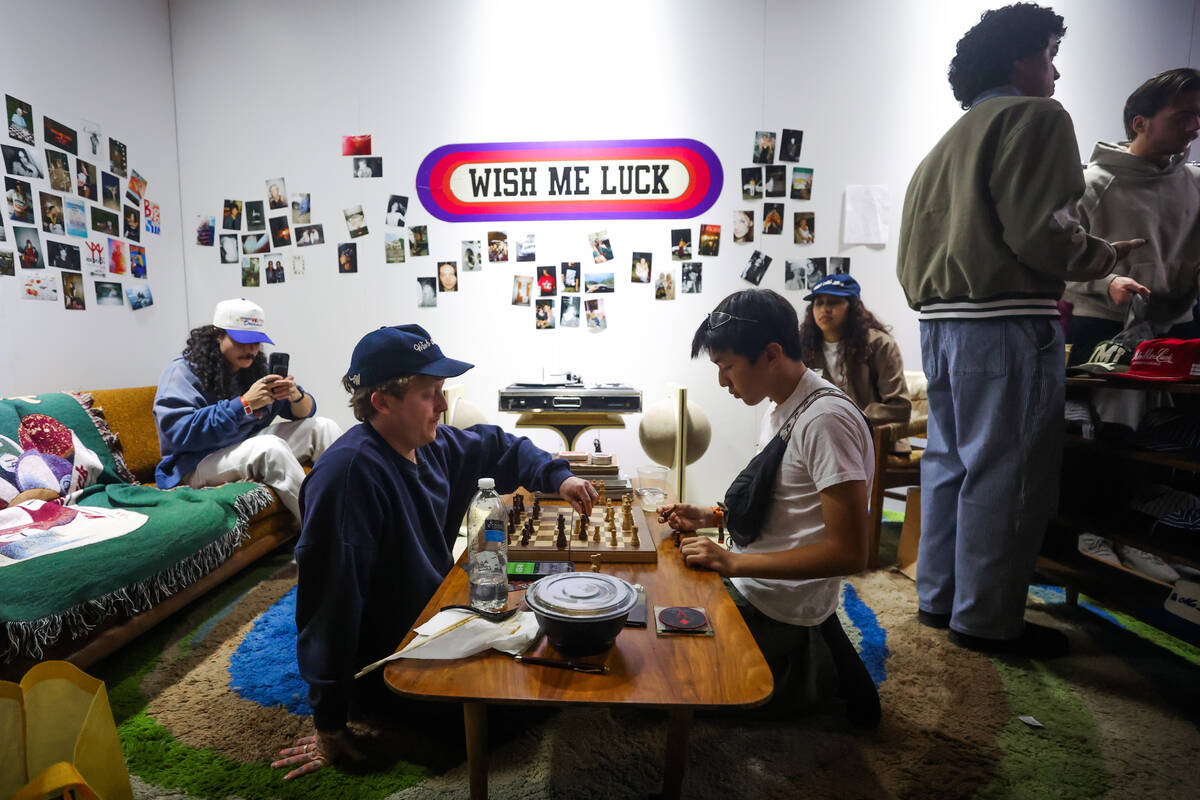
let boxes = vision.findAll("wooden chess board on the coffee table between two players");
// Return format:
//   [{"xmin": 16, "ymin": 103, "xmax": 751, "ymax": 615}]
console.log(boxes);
[{"xmin": 509, "ymin": 500, "xmax": 659, "ymax": 565}]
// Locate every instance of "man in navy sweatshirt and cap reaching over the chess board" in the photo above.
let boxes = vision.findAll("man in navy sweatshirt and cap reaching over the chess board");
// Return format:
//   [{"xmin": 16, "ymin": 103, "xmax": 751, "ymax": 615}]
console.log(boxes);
[{"xmin": 275, "ymin": 325, "xmax": 595, "ymax": 778}]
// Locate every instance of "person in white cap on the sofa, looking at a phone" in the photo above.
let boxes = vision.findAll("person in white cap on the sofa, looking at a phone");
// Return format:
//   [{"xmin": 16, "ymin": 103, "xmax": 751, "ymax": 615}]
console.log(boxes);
[{"xmin": 154, "ymin": 297, "xmax": 342, "ymax": 519}]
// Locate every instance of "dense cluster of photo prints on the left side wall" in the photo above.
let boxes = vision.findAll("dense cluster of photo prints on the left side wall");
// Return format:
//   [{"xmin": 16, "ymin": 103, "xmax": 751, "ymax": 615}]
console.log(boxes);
[{"xmin": 0, "ymin": 94, "xmax": 162, "ymax": 311}]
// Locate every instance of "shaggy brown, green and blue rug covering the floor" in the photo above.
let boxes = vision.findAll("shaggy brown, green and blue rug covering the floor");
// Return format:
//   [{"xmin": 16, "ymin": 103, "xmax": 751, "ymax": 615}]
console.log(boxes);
[{"xmin": 91, "ymin": 537, "xmax": 1200, "ymax": 800}]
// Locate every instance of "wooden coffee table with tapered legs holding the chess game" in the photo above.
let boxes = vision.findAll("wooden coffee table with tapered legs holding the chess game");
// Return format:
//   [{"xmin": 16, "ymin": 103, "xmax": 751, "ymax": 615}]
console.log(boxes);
[{"xmin": 384, "ymin": 503, "xmax": 773, "ymax": 799}]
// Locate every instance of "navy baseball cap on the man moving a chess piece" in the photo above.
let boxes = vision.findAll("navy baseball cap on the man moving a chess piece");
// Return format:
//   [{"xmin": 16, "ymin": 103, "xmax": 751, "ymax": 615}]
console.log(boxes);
[{"xmin": 346, "ymin": 325, "xmax": 475, "ymax": 386}]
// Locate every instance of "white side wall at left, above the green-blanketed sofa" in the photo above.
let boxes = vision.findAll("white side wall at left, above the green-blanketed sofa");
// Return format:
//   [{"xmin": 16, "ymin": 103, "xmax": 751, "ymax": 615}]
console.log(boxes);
[{"xmin": 0, "ymin": 0, "xmax": 187, "ymax": 396}]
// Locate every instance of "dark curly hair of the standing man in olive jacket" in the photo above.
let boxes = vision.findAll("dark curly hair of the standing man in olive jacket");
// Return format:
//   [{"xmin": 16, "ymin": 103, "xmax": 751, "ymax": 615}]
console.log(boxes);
[{"xmin": 947, "ymin": 2, "xmax": 1067, "ymax": 109}]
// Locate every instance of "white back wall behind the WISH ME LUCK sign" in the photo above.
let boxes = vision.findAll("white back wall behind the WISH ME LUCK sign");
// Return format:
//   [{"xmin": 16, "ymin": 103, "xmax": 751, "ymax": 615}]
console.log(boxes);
[{"xmin": 154, "ymin": 0, "xmax": 1198, "ymax": 503}]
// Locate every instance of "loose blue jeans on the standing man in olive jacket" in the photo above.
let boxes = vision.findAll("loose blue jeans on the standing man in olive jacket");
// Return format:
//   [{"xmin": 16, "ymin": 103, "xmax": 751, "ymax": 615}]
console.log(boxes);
[{"xmin": 917, "ymin": 318, "xmax": 1064, "ymax": 639}]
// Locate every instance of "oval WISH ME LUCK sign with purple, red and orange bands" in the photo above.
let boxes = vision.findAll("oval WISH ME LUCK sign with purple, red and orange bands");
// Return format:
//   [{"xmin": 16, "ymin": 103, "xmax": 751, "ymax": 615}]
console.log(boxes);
[{"xmin": 416, "ymin": 139, "xmax": 722, "ymax": 222}]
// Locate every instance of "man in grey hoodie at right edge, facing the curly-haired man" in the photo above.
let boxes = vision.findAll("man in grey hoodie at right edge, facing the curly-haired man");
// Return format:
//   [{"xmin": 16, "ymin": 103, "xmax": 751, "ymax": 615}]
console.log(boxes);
[{"xmin": 1063, "ymin": 68, "xmax": 1200, "ymax": 365}]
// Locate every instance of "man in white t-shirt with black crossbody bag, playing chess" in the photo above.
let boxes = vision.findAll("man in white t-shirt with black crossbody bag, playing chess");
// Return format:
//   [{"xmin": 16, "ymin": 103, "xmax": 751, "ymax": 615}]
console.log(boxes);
[{"xmin": 660, "ymin": 289, "xmax": 880, "ymax": 727}]
